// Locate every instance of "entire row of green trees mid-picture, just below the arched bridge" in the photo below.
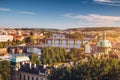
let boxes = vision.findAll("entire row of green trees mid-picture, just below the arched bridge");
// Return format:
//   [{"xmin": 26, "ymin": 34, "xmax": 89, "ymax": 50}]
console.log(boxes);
[{"xmin": 41, "ymin": 47, "xmax": 82, "ymax": 64}]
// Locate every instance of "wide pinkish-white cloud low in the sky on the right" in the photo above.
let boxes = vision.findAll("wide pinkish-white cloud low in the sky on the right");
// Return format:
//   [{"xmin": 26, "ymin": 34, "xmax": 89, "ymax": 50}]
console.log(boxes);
[{"xmin": 64, "ymin": 13, "xmax": 120, "ymax": 26}]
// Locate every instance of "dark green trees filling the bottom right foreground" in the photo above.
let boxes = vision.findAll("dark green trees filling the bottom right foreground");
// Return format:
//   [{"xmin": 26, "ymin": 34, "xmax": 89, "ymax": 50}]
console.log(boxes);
[{"xmin": 48, "ymin": 58, "xmax": 120, "ymax": 80}]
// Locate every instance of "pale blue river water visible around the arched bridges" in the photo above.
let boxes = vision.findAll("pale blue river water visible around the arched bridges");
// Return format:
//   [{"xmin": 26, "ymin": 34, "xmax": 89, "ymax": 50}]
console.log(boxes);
[{"xmin": 28, "ymin": 34, "xmax": 88, "ymax": 54}]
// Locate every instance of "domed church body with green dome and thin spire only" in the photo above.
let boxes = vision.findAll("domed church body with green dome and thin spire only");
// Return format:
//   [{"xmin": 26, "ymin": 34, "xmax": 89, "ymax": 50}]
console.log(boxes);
[{"xmin": 97, "ymin": 33, "xmax": 112, "ymax": 55}]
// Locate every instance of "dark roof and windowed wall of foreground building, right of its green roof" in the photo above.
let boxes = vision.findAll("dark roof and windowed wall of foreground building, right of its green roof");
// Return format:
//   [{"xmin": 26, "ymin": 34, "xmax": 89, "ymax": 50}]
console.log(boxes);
[{"xmin": 17, "ymin": 64, "xmax": 47, "ymax": 80}]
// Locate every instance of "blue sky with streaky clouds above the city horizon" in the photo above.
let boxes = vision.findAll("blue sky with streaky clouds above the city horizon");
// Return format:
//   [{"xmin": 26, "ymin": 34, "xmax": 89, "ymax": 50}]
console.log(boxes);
[{"xmin": 0, "ymin": 0, "xmax": 120, "ymax": 29}]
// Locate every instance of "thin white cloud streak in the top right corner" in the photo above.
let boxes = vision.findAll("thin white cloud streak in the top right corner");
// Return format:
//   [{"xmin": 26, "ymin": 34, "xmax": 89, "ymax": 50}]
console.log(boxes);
[{"xmin": 93, "ymin": 0, "xmax": 120, "ymax": 6}]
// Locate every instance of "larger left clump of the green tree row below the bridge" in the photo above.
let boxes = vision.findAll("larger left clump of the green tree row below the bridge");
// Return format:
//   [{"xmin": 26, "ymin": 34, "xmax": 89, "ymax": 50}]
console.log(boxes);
[{"xmin": 41, "ymin": 47, "xmax": 66, "ymax": 64}]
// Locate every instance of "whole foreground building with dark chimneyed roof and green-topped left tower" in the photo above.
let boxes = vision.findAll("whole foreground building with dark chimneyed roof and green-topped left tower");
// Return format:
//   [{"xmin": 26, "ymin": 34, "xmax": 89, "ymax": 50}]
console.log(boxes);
[{"xmin": 10, "ymin": 56, "xmax": 49, "ymax": 80}]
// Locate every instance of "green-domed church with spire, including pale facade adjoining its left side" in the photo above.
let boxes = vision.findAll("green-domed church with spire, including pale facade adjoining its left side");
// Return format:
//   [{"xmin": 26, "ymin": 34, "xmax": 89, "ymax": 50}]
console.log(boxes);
[{"xmin": 85, "ymin": 33, "xmax": 112, "ymax": 55}]
